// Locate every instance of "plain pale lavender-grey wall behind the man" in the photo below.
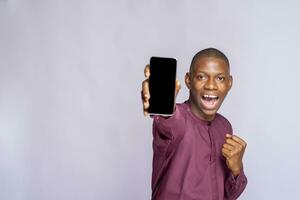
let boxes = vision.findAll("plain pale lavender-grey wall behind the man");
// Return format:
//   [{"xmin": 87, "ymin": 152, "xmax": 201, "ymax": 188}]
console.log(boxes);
[{"xmin": 0, "ymin": 0, "xmax": 300, "ymax": 200}]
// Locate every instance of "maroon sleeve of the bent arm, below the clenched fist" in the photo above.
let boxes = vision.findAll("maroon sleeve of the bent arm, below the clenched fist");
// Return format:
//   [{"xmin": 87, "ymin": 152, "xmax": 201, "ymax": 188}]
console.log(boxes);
[{"xmin": 225, "ymin": 169, "xmax": 248, "ymax": 200}]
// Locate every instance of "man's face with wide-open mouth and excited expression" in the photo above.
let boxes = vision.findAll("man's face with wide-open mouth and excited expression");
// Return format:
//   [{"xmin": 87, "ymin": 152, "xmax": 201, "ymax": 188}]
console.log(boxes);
[{"xmin": 185, "ymin": 57, "xmax": 232, "ymax": 121}]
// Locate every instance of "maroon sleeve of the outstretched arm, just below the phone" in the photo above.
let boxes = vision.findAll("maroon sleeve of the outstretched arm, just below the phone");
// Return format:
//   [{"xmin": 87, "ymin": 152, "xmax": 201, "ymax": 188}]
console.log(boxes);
[{"xmin": 153, "ymin": 105, "xmax": 185, "ymax": 154}]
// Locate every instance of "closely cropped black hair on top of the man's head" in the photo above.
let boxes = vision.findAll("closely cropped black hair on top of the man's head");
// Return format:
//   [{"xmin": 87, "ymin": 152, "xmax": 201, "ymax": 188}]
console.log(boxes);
[{"xmin": 190, "ymin": 47, "xmax": 230, "ymax": 74}]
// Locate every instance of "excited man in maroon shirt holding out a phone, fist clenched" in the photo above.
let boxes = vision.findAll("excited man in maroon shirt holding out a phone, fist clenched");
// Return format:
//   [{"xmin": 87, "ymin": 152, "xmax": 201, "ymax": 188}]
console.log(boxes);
[{"xmin": 142, "ymin": 48, "xmax": 247, "ymax": 200}]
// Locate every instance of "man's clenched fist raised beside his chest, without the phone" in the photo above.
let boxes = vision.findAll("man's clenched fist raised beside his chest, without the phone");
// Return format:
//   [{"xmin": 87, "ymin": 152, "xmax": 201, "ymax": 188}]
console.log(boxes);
[{"xmin": 222, "ymin": 134, "xmax": 247, "ymax": 177}]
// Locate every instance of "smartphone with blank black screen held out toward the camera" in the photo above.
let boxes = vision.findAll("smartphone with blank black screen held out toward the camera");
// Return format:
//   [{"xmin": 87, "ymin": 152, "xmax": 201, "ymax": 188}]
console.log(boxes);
[{"xmin": 148, "ymin": 57, "xmax": 177, "ymax": 116}]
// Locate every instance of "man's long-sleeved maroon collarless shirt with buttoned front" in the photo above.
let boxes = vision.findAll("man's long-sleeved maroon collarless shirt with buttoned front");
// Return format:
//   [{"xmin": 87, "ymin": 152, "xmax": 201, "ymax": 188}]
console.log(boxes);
[{"xmin": 152, "ymin": 102, "xmax": 247, "ymax": 200}]
